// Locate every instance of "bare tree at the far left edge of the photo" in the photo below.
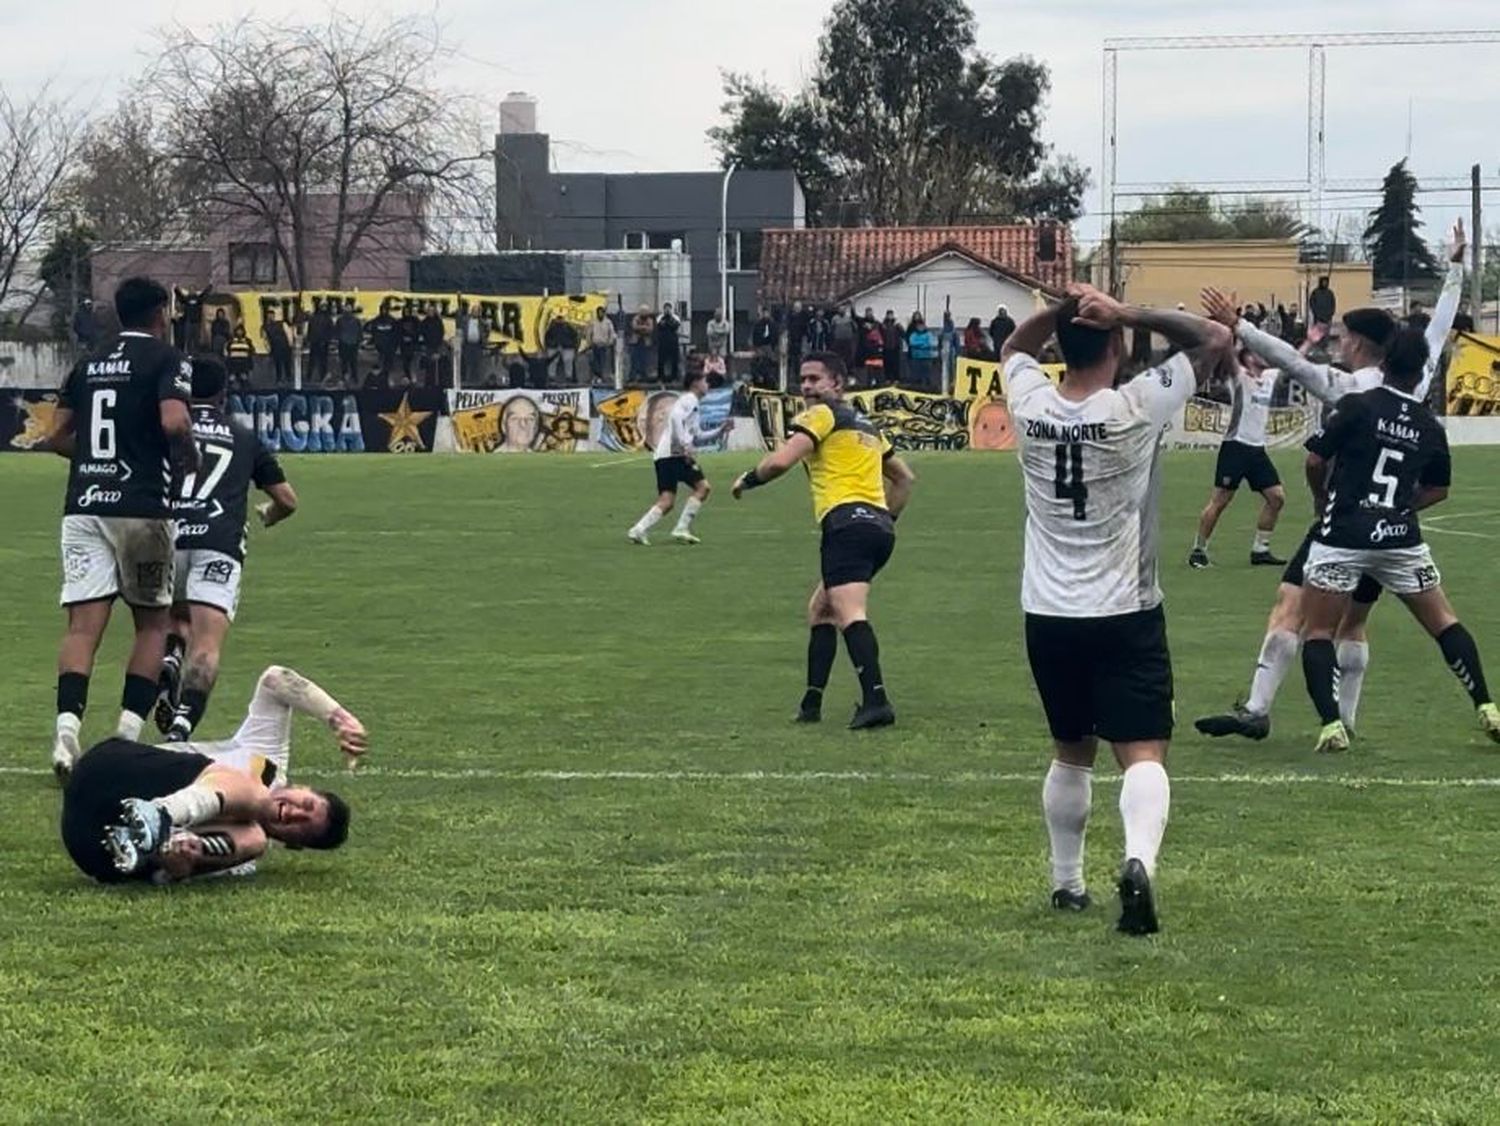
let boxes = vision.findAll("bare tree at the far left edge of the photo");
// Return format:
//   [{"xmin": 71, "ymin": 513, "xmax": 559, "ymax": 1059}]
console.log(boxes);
[{"xmin": 0, "ymin": 87, "xmax": 81, "ymax": 322}]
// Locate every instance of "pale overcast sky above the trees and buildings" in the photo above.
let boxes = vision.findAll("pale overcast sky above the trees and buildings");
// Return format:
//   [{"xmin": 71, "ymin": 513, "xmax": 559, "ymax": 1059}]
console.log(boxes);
[{"xmin": 11, "ymin": 0, "xmax": 1500, "ymax": 238}]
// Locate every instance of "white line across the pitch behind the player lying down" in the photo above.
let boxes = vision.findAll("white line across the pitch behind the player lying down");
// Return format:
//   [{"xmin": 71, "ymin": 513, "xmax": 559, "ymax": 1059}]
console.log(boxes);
[{"xmin": 11, "ymin": 766, "xmax": 1500, "ymax": 790}]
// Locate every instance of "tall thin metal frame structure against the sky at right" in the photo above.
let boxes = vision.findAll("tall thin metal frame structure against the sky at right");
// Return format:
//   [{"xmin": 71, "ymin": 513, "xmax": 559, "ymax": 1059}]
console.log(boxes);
[{"xmin": 1100, "ymin": 30, "xmax": 1500, "ymax": 295}]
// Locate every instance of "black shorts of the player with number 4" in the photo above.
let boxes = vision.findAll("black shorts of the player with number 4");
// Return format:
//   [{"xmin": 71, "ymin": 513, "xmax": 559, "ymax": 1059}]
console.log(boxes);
[{"xmin": 1026, "ymin": 606, "xmax": 1173, "ymax": 742}]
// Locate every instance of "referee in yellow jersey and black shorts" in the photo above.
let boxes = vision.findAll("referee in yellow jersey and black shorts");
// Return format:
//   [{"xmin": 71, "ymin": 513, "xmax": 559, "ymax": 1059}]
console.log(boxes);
[{"xmin": 731, "ymin": 352, "xmax": 917, "ymax": 730}]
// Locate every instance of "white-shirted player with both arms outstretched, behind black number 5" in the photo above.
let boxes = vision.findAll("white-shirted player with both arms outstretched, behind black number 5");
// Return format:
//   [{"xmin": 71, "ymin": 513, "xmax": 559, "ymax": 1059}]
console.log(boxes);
[{"xmin": 1196, "ymin": 222, "xmax": 1467, "ymax": 739}]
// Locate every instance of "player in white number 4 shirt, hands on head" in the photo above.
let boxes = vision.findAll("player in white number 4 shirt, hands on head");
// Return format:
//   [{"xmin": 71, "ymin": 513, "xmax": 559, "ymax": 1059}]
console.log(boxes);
[{"xmin": 1002, "ymin": 286, "xmax": 1230, "ymax": 934}]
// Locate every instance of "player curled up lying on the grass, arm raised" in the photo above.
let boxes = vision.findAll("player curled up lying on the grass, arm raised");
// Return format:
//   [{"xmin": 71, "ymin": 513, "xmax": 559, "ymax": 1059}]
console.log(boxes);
[{"xmin": 62, "ymin": 666, "xmax": 369, "ymax": 883}]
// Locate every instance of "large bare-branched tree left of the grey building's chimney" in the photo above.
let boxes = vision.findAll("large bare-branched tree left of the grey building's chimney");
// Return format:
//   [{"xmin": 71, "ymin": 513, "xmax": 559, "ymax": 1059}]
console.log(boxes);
[{"xmin": 138, "ymin": 13, "xmax": 488, "ymax": 289}]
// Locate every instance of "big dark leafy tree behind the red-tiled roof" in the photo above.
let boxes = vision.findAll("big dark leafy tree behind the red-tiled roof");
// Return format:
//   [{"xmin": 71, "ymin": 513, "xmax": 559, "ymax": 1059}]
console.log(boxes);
[{"xmin": 710, "ymin": 0, "xmax": 1088, "ymax": 225}]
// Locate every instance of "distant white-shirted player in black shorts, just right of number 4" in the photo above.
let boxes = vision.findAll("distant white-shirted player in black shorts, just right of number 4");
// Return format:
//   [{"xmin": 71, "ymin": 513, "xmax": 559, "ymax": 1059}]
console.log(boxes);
[{"xmin": 1188, "ymin": 348, "xmax": 1287, "ymax": 568}]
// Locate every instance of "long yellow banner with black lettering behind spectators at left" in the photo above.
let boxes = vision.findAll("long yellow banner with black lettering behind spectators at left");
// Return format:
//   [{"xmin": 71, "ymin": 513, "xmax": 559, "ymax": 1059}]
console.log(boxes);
[{"xmin": 231, "ymin": 289, "xmax": 609, "ymax": 355}]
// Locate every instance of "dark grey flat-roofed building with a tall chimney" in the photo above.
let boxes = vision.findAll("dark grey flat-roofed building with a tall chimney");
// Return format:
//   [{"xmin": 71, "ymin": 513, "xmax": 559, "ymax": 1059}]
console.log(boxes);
[{"xmin": 495, "ymin": 94, "xmax": 806, "ymax": 339}]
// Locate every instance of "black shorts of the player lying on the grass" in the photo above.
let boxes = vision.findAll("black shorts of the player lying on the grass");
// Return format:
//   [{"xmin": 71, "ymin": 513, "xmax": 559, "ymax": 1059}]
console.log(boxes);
[{"xmin": 62, "ymin": 739, "xmax": 212, "ymax": 883}]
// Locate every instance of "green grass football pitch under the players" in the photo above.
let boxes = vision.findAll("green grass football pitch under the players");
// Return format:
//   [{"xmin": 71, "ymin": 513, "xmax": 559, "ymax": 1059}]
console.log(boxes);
[{"xmin": 0, "ymin": 450, "xmax": 1500, "ymax": 1123}]
